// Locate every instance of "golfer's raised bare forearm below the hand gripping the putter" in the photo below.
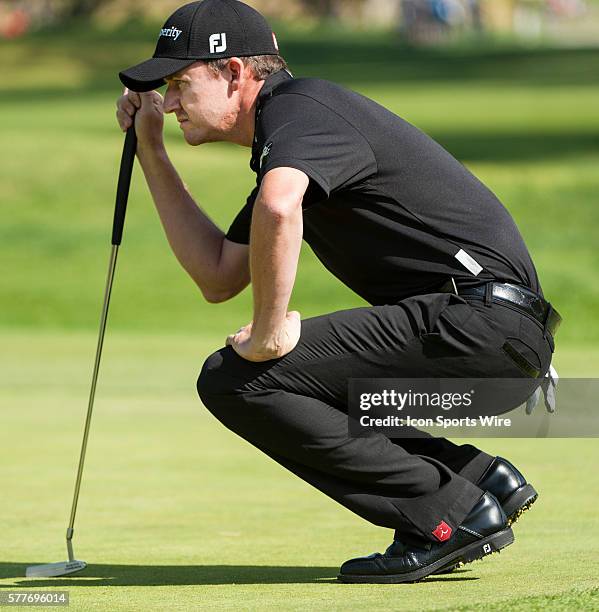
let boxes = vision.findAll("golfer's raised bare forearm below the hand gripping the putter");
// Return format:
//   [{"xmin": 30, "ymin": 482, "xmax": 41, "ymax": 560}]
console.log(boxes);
[{"xmin": 138, "ymin": 147, "xmax": 225, "ymax": 295}]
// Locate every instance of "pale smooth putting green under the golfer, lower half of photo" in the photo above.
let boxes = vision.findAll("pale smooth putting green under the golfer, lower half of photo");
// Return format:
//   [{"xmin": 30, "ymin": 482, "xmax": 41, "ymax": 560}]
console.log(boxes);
[{"xmin": 0, "ymin": 333, "xmax": 599, "ymax": 610}]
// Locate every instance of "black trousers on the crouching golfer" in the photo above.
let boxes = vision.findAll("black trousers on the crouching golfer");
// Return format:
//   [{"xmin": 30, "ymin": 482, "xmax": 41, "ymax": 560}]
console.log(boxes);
[{"xmin": 198, "ymin": 293, "xmax": 552, "ymax": 541}]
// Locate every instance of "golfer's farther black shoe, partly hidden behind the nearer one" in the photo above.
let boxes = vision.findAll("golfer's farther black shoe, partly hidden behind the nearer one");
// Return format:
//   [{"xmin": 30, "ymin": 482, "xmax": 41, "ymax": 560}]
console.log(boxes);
[{"xmin": 476, "ymin": 457, "xmax": 539, "ymax": 525}]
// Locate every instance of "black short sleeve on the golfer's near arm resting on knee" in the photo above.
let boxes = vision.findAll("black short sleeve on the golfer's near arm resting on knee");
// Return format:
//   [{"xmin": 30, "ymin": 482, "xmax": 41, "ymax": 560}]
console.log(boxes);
[{"xmin": 258, "ymin": 94, "xmax": 376, "ymax": 204}]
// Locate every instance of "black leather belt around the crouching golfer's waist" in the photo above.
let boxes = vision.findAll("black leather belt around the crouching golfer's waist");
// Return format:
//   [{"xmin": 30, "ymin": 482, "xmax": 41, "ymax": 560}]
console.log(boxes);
[{"xmin": 446, "ymin": 282, "xmax": 562, "ymax": 336}]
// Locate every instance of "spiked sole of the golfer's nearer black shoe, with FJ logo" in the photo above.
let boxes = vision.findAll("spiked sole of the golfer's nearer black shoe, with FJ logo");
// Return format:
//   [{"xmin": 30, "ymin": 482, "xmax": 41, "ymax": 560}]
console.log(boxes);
[{"xmin": 337, "ymin": 527, "xmax": 514, "ymax": 584}]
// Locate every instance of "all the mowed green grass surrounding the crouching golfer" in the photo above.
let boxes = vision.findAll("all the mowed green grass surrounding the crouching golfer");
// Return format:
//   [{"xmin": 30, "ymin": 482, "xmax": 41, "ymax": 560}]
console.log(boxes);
[{"xmin": 0, "ymin": 20, "xmax": 599, "ymax": 610}]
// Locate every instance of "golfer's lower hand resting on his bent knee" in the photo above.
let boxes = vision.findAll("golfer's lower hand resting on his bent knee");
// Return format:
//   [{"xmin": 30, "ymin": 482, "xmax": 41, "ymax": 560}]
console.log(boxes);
[{"xmin": 226, "ymin": 311, "xmax": 302, "ymax": 361}]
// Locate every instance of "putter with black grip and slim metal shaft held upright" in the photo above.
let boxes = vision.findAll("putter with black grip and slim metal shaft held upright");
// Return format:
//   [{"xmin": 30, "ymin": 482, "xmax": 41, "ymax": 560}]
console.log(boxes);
[{"xmin": 25, "ymin": 126, "xmax": 137, "ymax": 578}]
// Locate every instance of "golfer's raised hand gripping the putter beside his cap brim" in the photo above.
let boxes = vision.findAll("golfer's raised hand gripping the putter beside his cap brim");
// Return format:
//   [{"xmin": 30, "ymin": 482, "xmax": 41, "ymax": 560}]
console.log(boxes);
[{"xmin": 116, "ymin": 88, "xmax": 164, "ymax": 149}]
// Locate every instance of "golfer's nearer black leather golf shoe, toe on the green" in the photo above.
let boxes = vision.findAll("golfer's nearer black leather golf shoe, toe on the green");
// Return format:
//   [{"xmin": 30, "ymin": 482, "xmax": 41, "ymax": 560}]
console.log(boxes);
[{"xmin": 337, "ymin": 493, "xmax": 514, "ymax": 583}]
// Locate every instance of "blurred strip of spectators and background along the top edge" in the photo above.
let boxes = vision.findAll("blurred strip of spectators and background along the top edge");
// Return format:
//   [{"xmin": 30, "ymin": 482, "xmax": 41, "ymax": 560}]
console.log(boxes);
[{"xmin": 1, "ymin": 0, "xmax": 599, "ymax": 44}]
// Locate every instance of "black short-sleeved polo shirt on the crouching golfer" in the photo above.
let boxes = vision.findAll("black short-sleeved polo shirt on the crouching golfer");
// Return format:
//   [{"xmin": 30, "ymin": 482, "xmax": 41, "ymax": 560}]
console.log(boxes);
[{"xmin": 227, "ymin": 71, "xmax": 540, "ymax": 304}]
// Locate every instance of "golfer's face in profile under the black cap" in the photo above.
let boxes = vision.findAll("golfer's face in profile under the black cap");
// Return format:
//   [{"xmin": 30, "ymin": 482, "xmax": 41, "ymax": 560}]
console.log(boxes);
[{"xmin": 164, "ymin": 62, "xmax": 239, "ymax": 145}]
